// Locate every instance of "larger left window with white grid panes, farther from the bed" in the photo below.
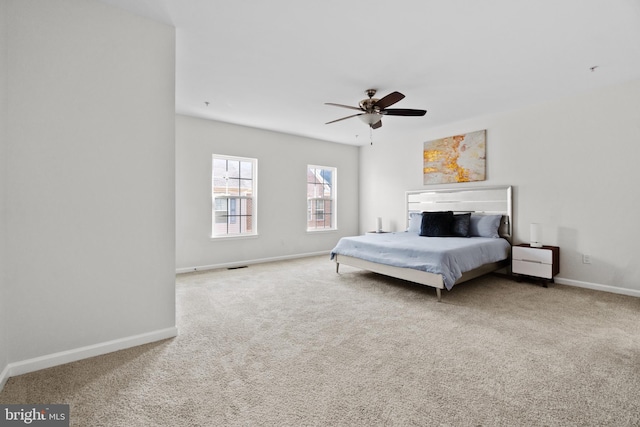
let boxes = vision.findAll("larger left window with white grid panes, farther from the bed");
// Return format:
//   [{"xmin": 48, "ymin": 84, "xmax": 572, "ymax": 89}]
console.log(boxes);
[{"xmin": 211, "ymin": 154, "xmax": 258, "ymax": 237}]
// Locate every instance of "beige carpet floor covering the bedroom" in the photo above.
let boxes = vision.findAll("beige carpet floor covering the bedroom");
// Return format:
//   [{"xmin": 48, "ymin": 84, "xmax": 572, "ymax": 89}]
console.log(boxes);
[{"xmin": 0, "ymin": 257, "xmax": 640, "ymax": 427}]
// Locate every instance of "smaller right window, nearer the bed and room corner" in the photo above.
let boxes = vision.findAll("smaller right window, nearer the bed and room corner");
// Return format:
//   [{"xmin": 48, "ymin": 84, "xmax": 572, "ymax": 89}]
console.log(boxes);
[{"xmin": 307, "ymin": 165, "xmax": 336, "ymax": 231}]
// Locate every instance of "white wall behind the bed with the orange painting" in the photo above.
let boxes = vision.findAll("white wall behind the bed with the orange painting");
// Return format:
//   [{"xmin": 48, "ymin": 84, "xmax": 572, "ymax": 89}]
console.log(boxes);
[{"xmin": 360, "ymin": 81, "xmax": 640, "ymax": 296}]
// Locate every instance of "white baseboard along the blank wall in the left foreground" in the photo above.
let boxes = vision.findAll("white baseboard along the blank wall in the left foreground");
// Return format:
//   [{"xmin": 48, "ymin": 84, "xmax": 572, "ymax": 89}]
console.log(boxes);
[{"xmin": 0, "ymin": 326, "xmax": 178, "ymax": 390}]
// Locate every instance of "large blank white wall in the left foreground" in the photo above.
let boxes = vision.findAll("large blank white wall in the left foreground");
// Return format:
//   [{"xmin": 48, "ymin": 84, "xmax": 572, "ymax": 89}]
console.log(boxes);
[{"xmin": 0, "ymin": 0, "xmax": 175, "ymax": 375}]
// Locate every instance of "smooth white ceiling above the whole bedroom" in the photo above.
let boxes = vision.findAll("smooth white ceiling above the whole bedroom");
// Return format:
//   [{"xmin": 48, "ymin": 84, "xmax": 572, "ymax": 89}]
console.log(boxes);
[{"xmin": 101, "ymin": 0, "xmax": 640, "ymax": 145}]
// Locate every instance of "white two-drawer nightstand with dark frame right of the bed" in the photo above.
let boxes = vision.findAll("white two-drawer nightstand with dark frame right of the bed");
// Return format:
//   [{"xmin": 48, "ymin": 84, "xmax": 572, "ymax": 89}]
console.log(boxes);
[{"xmin": 511, "ymin": 243, "xmax": 560, "ymax": 283}]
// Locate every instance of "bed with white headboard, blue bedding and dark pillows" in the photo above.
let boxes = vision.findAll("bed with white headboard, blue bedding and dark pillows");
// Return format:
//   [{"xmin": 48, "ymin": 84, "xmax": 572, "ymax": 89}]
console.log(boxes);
[{"xmin": 331, "ymin": 186, "xmax": 513, "ymax": 301}]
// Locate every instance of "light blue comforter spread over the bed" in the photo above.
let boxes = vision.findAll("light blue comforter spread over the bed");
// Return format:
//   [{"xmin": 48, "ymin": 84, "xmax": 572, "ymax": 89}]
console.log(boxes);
[{"xmin": 331, "ymin": 232, "xmax": 511, "ymax": 290}]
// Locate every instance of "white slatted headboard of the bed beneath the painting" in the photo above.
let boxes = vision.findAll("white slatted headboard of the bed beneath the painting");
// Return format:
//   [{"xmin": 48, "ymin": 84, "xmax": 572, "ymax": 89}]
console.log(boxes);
[{"xmin": 406, "ymin": 185, "xmax": 513, "ymax": 241}]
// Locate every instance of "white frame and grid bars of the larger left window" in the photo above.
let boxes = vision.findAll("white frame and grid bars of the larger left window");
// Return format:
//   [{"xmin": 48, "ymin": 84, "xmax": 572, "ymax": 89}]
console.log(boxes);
[{"xmin": 210, "ymin": 154, "xmax": 258, "ymax": 240}]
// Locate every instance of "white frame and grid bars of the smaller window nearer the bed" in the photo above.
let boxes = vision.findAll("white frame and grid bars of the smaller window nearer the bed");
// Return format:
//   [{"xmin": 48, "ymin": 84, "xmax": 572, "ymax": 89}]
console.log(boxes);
[{"xmin": 306, "ymin": 164, "xmax": 338, "ymax": 233}]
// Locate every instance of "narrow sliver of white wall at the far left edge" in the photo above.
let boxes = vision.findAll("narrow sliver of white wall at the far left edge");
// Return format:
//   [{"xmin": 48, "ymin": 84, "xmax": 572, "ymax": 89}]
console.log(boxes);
[{"xmin": 0, "ymin": 1, "xmax": 9, "ymax": 388}]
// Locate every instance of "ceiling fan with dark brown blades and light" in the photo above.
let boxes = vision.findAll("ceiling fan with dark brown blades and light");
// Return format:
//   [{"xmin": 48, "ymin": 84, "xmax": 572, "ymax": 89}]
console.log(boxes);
[{"xmin": 325, "ymin": 89, "xmax": 427, "ymax": 129}]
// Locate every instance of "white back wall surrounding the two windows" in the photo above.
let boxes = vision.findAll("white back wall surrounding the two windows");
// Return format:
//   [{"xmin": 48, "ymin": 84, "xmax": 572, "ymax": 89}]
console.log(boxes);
[{"xmin": 176, "ymin": 115, "xmax": 358, "ymax": 271}]
